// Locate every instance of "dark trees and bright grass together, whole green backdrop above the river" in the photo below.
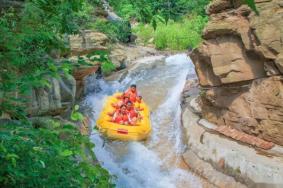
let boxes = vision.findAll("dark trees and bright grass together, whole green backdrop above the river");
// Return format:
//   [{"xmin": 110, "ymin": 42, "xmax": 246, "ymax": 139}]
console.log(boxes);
[{"xmin": 109, "ymin": 0, "xmax": 209, "ymax": 50}]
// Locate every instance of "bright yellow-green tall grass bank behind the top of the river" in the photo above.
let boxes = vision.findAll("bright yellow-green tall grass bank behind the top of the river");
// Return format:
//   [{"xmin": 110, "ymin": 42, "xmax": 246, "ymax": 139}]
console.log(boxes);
[{"xmin": 134, "ymin": 16, "xmax": 207, "ymax": 50}]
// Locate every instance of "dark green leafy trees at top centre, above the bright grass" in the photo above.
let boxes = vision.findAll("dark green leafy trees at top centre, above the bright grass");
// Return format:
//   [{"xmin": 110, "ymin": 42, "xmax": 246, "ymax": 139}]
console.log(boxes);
[{"xmin": 109, "ymin": 0, "xmax": 209, "ymax": 27}]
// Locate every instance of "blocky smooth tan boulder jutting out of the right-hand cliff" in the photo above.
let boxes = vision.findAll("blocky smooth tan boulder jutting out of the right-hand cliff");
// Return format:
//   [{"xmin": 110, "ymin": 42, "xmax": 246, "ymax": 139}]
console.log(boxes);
[{"xmin": 195, "ymin": 36, "xmax": 265, "ymax": 86}]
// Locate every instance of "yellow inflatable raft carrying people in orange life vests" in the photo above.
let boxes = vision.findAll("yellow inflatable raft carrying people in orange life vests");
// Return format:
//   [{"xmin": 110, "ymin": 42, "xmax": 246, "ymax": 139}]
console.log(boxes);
[{"xmin": 96, "ymin": 93, "xmax": 151, "ymax": 141}]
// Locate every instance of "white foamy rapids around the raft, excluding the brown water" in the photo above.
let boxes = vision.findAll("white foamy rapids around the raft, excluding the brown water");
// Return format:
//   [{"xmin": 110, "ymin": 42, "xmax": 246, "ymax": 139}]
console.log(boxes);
[{"xmin": 85, "ymin": 54, "xmax": 201, "ymax": 188}]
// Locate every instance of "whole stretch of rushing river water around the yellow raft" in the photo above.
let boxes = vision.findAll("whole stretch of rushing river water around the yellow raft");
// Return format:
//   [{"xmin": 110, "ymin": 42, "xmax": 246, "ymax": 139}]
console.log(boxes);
[{"xmin": 85, "ymin": 54, "xmax": 202, "ymax": 188}]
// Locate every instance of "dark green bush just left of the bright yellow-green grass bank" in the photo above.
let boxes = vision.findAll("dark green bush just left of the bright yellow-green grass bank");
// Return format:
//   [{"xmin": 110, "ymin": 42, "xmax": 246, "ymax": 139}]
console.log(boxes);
[{"xmin": 89, "ymin": 19, "xmax": 131, "ymax": 43}]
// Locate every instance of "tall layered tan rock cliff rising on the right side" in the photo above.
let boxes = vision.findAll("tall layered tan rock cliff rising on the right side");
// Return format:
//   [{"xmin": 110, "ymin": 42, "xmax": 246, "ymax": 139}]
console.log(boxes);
[{"xmin": 191, "ymin": 0, "xmax": 283, "ymax": 145}]
